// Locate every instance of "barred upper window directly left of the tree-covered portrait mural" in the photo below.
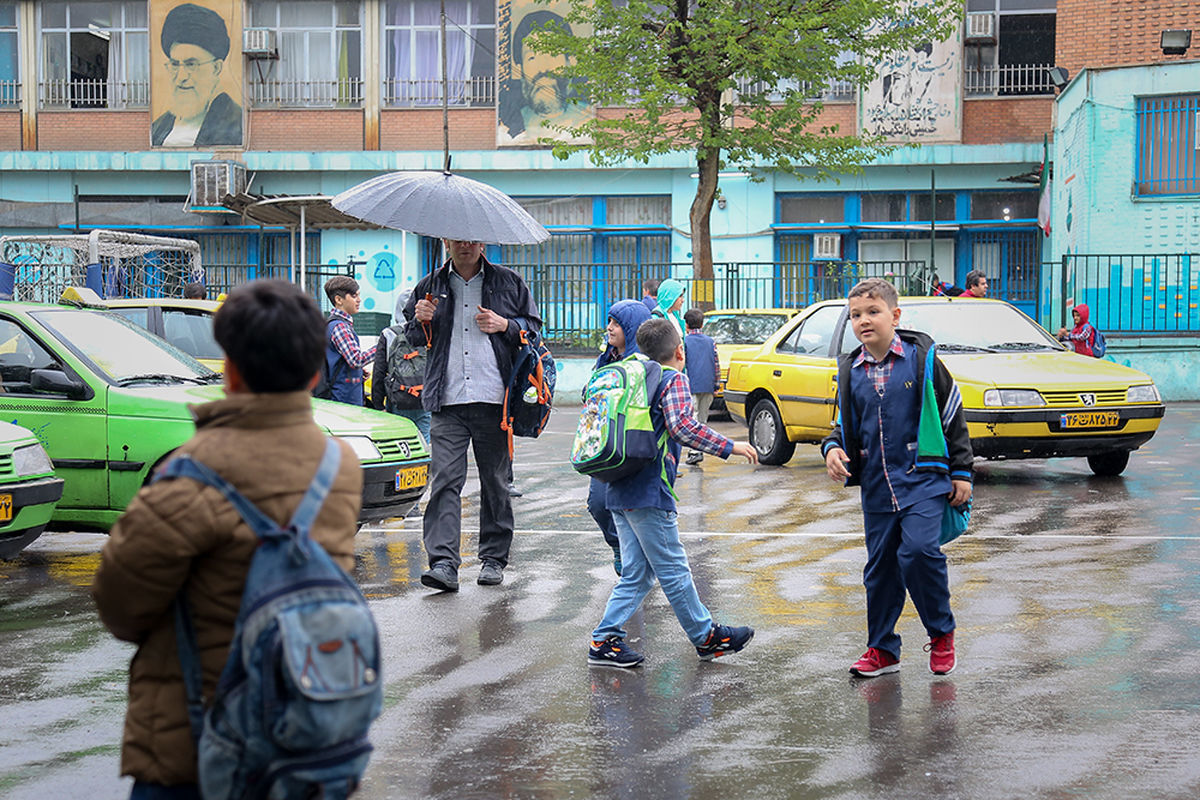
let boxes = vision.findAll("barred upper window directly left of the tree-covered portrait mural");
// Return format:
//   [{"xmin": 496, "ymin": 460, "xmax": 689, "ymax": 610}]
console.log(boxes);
[{"xmin": 383, "ymin": 0, "xmax": 496, "ymax": 107}]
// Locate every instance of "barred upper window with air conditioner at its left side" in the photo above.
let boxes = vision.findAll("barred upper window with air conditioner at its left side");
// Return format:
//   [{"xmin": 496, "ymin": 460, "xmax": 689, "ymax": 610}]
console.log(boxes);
[{"xmin": 247, "ymin": 0, "xmax": 362, "ymax": 108}]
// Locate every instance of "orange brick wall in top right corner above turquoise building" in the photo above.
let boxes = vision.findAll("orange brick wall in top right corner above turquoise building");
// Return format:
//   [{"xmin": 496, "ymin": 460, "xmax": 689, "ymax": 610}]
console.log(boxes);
[{"xmin": 1055, "ymin": 0, "xmax": 1200, "ymax": 77}]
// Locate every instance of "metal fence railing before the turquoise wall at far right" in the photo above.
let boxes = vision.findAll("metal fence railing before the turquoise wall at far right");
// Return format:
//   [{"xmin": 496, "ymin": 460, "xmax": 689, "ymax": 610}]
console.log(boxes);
[{"xmin": 1039, "ymin": 253, "xmax": 1200, "ymax": 336}]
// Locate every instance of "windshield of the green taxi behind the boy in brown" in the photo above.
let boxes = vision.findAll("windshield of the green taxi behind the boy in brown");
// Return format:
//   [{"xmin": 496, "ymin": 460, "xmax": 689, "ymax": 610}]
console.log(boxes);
[{"xmin": 31, "ymin": 308, "xmax": 216, "ymax": 385}]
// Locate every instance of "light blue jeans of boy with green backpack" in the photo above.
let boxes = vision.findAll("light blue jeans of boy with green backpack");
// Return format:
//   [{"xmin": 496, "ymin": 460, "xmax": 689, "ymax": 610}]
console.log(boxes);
[{"xmin": 592, "ymin": 509, "xmax": 713, "ymax": 645}]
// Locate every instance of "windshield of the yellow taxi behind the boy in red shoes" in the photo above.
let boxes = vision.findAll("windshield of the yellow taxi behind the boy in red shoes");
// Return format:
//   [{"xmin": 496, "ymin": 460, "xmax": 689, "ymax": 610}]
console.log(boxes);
[{"xmin": 842, "ymin": 300, "xmax": 1063, "ymax": 353}]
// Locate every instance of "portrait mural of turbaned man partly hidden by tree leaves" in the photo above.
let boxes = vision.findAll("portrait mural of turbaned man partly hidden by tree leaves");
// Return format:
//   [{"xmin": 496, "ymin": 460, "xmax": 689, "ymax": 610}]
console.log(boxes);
[{"xmin": 496, "ymin": 0, "xmax": 594, "ymax": 146}]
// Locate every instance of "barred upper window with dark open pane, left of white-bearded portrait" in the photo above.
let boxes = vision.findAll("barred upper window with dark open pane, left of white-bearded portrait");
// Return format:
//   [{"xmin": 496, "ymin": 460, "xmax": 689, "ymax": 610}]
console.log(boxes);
[{"xmin": 39, "ymin": 1, "xmax": 150, "ymax": 108}]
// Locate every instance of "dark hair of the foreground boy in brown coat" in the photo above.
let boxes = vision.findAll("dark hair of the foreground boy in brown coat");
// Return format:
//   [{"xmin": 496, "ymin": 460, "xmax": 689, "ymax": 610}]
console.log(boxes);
[{"xmin": 212, "ymin": 281, "xmax": 325, "ymax": 392}]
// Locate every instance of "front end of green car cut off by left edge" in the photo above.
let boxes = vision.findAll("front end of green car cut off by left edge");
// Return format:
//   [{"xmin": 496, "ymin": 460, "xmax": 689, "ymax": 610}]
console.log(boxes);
[{"xmin": 0, "ymin": 422, "xmax": 62, "ymax": 559}]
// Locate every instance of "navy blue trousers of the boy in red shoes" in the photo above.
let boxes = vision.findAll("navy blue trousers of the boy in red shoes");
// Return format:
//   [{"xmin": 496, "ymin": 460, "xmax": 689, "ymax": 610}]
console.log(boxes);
[{"xmin": 863, "ymin": 494, "xmax": 954, "ymax": 658}]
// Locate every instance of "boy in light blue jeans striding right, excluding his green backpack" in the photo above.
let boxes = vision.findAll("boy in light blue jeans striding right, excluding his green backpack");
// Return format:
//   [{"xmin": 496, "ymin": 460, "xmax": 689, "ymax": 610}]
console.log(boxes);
[{"xmin": 588, "ymin": 319, "xmax": 758, "ymax": 667}]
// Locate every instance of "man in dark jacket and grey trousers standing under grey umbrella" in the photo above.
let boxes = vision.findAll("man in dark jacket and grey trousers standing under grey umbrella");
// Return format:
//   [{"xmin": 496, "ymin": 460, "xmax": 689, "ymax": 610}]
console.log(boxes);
[{"xmin": 403, "ymin": 239, "xmax": 541, "ymax": 591}]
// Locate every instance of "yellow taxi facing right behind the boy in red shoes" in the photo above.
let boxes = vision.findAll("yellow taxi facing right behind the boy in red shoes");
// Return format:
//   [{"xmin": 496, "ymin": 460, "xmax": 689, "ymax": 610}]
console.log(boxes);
[{"xmin": 725, "ymin": 297, "xmax": 1165, "ymax": 475}]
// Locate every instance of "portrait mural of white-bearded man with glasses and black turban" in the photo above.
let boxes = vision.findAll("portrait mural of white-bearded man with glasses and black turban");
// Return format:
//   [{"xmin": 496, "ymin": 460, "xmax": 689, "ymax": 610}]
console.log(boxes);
[{"xmin": 150, "ymin": 0, "xmax": 242, "ymax": 148}]
